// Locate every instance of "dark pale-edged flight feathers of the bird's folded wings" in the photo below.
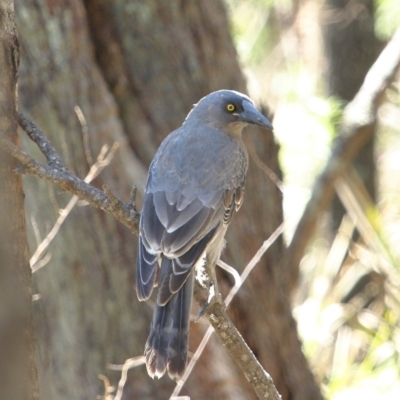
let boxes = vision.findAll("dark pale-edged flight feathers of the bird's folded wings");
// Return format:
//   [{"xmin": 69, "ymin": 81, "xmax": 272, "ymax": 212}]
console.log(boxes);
[{"xmin": 138, "ymin": 186, "xmax": 224, "ymax": 305}]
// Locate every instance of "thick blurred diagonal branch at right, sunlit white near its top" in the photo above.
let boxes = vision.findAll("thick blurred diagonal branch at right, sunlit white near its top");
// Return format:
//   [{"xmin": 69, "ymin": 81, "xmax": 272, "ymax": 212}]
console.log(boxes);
[{"xmin": 282, "ymin": 29, "xmax": 400, "ymax": 284}]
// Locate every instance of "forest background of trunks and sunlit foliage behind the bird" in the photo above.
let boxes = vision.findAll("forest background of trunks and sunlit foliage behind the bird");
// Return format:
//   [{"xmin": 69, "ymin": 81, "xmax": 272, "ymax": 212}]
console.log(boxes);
[{"xmin": 0, "ymin": 0, "xmax": 400, "ymax": 400}]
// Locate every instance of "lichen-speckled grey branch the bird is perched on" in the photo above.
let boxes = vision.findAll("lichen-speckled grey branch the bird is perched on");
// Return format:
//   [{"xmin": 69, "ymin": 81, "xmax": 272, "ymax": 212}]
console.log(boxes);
[{"xmin": 0, "ymin": 114, "xmax": 280, "ymax": 400}]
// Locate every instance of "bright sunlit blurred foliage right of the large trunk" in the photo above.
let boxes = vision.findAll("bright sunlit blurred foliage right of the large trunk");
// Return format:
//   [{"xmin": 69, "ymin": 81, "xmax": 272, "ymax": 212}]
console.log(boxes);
[{"xmin": 226, "ymin": 0, "xmax": 400, "ymax": 400}]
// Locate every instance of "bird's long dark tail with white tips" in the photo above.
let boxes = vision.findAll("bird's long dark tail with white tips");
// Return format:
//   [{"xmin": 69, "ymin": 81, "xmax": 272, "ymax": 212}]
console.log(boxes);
[{"xmin": 144, "ymin": 259, "xmax": 194, "ymax": 379}]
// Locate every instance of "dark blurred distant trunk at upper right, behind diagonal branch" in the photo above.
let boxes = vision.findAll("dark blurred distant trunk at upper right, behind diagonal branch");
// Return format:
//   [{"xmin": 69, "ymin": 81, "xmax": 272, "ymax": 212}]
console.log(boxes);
[{"xmin": 324, "ymin": 0, "xmax": 379, "ymax": 234}]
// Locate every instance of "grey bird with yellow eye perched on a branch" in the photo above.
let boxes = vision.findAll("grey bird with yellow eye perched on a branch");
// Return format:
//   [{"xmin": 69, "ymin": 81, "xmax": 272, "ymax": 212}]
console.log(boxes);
[{"xmin": 136, "ymin": 90, "xmax": 273, "ymax": 379}]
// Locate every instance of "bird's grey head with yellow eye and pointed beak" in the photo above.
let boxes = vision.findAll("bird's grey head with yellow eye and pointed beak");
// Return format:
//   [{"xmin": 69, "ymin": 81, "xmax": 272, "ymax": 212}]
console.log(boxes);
[{"xmin": 186, "ymin": 90, "xmax": 273, "ymax": 134}]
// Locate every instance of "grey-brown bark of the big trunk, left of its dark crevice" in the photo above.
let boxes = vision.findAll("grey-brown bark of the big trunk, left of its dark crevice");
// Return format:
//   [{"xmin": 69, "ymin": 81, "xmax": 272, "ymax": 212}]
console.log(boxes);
[{"xmin": 16, "ymin": 1, "xmax": 152, "ymax": 400}]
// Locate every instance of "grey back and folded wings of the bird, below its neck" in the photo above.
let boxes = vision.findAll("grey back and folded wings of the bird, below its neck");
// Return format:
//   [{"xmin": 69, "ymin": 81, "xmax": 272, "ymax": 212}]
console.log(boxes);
[{"xmin": 138, "ymin": 128, "xmax": 247, "ymax": 304}]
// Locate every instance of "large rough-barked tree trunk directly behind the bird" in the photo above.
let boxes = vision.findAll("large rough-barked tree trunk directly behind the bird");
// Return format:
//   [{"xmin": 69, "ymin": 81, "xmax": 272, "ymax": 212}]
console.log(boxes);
[{"xmin": 17, "ymin": 0, "xmax": 321, "ymax": 400}]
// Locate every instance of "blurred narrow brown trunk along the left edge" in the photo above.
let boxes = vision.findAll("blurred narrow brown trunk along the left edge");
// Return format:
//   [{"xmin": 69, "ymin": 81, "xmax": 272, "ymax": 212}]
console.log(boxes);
[{"xmin": 0, "ymin": 0, "xmax": 39, "ymax": 400}]
